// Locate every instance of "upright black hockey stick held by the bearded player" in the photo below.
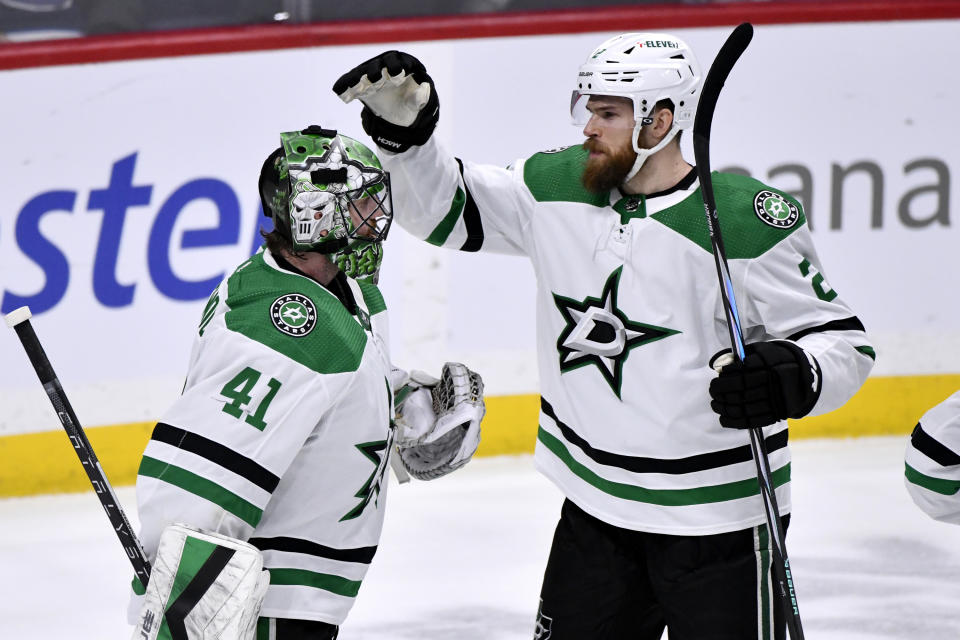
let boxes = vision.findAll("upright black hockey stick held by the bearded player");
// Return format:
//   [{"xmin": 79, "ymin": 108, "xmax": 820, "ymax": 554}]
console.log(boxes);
[{"xmin": 693, "ymin": 22, "xmax": 803, "ymax": 640}]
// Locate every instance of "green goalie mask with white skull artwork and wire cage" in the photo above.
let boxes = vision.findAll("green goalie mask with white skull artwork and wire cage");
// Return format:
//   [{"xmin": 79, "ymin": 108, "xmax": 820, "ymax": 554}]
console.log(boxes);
[{"xmin": 259, "ymin": 125, "xmax": 393, "ymax": 278}]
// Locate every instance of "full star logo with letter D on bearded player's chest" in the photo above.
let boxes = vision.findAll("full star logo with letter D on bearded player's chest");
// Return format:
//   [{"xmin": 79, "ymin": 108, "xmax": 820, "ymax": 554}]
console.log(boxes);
[{"xmin": 553, "ymin": 267, "xmax": 680, "ymax": 398}]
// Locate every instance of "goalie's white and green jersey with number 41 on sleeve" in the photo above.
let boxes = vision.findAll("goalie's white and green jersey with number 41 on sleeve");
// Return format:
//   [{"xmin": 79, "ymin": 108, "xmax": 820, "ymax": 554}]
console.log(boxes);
[{"xmin": 137, "ymin": 250, "xmax": 393, "ymax": 624}]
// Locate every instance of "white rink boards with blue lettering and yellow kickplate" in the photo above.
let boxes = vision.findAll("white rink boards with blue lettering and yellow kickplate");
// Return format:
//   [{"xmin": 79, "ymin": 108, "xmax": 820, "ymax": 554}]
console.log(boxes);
[{"xmin": 0, "ymin": 2, "xmax": 960, "ymax": 495}]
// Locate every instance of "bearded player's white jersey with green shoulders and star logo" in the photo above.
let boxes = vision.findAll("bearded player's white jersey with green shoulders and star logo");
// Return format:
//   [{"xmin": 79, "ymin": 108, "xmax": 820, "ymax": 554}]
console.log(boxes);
[{"xmin": 383, "ymin": 137, "xmax": 875, "ymax": 535}]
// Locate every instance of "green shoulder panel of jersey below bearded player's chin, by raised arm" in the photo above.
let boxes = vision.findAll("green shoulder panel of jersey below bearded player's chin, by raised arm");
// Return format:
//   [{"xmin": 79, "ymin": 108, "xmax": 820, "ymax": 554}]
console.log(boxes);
[{"xmin": 523, "ymin": 145, "xmax": 610, "ymax": 207}]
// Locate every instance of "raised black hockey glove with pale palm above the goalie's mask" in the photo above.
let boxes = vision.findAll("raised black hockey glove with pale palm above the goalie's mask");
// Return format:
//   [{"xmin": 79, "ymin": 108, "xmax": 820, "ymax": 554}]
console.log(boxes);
[{"xmin": 333, "ymin": 51, "xmax": 440, "ymax": 153}]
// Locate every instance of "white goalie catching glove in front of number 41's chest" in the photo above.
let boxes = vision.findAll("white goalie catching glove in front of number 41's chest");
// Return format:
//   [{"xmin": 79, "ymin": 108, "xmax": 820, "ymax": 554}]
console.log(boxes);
[{"xmin": 395, "ymin": 362, "xmax": 486, "ymax": 480}]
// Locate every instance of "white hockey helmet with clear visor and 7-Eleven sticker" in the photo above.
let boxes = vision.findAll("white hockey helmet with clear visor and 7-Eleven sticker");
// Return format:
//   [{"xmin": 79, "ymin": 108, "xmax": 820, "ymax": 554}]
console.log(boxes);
[{"xmin": 570, "ymin": 33, "xmax": 703, "ymax": 180}]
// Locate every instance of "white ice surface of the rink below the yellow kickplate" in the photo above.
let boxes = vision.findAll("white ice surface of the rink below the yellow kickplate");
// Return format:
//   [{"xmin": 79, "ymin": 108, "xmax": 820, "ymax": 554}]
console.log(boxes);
[{"xmin": 0, "ymin": 437, "xmax": 960, "ymax": 640}]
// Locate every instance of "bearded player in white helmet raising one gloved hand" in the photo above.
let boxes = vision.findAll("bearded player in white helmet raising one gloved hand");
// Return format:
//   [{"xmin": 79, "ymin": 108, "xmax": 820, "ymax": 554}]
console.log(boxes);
[{"xmin": 333, "ymin": 33, "xmax": 874, "ymax": 640}]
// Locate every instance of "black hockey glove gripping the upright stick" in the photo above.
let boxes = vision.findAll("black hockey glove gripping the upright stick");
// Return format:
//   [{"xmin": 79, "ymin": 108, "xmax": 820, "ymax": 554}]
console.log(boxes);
[{"xmin": 710, "ymin": 340, "xmax": 822, "ymax": 429}]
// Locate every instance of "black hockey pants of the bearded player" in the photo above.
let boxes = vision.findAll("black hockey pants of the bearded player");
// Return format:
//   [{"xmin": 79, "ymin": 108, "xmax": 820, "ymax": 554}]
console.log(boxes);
[{"xmin": 534, "ymin": 500, "xmax": 790, "ymax": 640}]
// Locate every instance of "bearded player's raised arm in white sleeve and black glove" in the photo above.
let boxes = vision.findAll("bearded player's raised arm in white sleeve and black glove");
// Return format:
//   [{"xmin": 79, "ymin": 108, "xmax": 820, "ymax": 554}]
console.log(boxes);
[{"xmin": 333, "ymin": 51, "xmax": 535, "ymax": 254}]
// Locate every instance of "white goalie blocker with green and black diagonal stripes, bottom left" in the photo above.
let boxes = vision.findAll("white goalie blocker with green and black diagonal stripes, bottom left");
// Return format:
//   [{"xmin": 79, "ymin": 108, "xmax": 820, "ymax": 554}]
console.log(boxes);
[{"xmin": 133, "ymin": 524, "xmax": 270, "ymax": 640}]
